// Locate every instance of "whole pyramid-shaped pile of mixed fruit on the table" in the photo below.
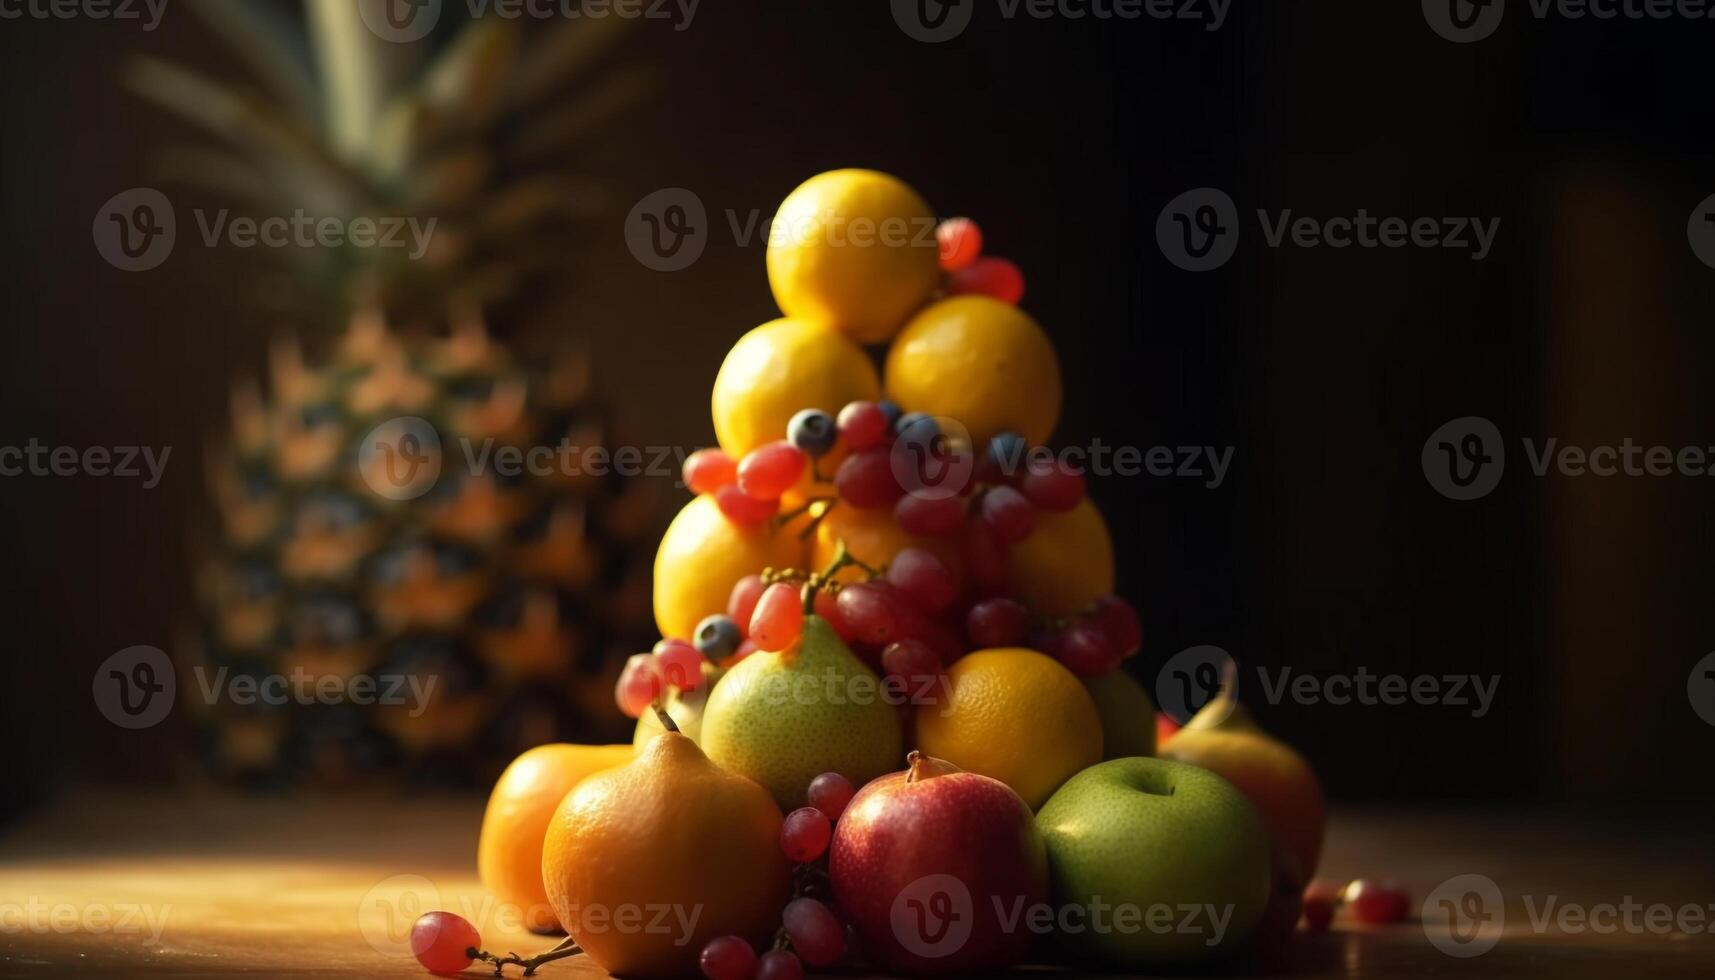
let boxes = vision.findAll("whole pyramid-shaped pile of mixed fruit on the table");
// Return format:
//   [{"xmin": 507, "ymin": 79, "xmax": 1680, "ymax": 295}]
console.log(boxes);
[{"xmin": 413, "ymin": 170, "xmax": 1385, "ymax": 980}]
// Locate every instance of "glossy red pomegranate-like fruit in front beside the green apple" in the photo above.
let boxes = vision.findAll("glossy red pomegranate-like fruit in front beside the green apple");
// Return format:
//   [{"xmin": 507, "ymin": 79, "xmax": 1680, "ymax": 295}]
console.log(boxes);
[{"xmin": 828, "ymin": 758, "xmax": 1048, "ymax": 975}]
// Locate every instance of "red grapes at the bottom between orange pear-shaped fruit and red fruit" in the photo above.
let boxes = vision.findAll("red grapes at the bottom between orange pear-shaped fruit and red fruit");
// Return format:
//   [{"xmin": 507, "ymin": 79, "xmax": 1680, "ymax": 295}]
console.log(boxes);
[{"xmin": 698, "ymin": 772, "xmax": 858, "ymax": 980}]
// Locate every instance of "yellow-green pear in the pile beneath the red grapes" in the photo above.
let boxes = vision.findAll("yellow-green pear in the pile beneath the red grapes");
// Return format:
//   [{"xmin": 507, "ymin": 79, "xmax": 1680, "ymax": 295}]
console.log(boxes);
[{"xmin": 701, "ymin": 616, "xmax": 902, "ymax": 810}]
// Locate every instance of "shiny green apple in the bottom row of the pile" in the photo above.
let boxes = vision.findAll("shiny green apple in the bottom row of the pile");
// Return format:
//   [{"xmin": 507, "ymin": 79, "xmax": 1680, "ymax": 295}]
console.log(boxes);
[{"xmin": 1036, "ymin": 759, "xmax": 1273, "ymax": 971}]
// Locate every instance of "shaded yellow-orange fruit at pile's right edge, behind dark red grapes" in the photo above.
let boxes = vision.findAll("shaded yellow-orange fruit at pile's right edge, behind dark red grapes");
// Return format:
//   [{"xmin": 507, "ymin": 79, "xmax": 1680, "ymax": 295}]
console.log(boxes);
[{"xmin": 1010, "ymin": 498, "xmax": 1113, "ymax": 616}]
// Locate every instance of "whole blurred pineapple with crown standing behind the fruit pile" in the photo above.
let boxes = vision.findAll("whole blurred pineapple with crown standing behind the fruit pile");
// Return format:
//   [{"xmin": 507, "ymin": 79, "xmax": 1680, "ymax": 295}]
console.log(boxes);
[{"xmin": 129, "ymin": 0, "xmax": 659, "ymax": 784}]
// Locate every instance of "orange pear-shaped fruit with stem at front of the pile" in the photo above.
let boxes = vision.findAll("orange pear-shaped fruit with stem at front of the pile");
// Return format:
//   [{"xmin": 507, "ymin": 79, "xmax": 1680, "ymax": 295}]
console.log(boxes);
[{"xmin": 542, "ymin": 733, "xmax": 792, "ymax": 978}]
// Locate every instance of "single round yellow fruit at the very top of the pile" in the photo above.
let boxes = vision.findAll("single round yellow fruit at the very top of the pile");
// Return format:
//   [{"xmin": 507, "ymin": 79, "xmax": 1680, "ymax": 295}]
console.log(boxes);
[{"xmin": 768, "ymin": 170, "xmax": 942, "ymax": 343}]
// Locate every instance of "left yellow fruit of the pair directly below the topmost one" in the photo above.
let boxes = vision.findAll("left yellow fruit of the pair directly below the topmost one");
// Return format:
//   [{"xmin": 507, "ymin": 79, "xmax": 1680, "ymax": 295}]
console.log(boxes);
[{"xmin": 710, "ymin": 318, "xmax": 882, "ymax": 460}]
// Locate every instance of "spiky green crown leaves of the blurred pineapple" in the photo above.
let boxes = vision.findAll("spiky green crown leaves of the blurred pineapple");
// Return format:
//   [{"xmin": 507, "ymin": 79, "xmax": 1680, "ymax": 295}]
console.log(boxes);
[{"xmin": 125, "ymin": 0, "xmax": 653, "ymax": 316}]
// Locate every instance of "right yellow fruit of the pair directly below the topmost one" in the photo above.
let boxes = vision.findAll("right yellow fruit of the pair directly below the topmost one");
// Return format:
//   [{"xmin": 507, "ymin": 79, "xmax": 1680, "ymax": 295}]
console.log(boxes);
[{"xmin": 887, "ymin": 295, "xmax": 1060, "ymax": 451}]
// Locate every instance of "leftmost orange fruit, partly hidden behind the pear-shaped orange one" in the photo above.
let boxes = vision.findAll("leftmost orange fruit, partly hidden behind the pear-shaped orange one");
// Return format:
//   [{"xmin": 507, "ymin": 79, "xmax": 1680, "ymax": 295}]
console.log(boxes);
[{"xmin": 476, "ymin": 743, "xmax": 633, "ymax": 933}]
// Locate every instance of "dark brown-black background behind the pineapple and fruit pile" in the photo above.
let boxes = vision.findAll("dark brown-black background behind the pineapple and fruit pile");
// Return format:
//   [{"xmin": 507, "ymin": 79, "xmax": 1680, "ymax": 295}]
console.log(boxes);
[{"xmin": 0, "ymin": 0, "xmax": 1715, "ymax": 808}]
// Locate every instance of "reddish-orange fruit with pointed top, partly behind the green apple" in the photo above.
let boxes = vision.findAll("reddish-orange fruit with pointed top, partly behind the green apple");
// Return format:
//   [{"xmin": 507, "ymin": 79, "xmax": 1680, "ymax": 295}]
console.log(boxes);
[{"xmin": 1159, "ymin": 728, "xmax": 1327, "ymax": 877}]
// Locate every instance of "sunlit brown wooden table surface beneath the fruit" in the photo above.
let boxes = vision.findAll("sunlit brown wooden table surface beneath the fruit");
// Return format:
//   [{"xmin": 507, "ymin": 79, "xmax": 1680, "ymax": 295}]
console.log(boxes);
[{"xmin": 0, "ymin": 795, "xmax": 1715, "ymax": 980}]
